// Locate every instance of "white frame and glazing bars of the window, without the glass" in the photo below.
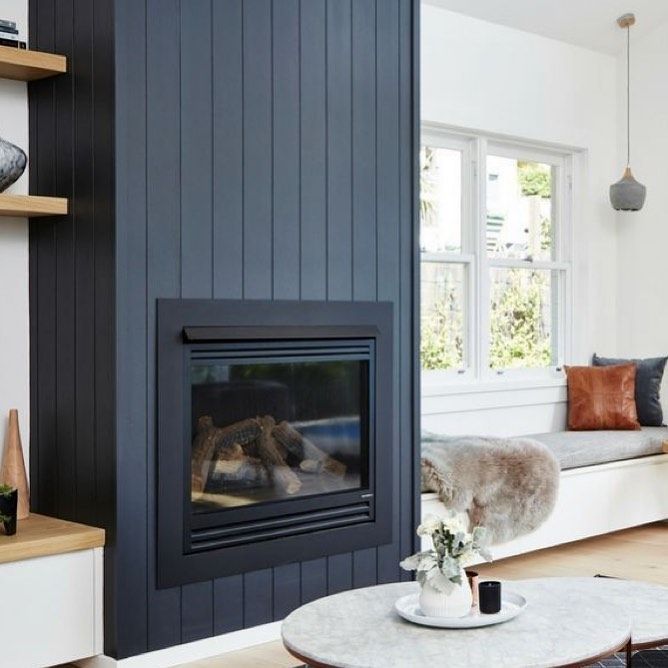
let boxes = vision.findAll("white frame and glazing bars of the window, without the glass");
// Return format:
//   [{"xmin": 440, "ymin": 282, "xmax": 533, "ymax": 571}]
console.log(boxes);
[{"xmin": 420, "ymin": 125, "xmax": 575, "ymax": 388}]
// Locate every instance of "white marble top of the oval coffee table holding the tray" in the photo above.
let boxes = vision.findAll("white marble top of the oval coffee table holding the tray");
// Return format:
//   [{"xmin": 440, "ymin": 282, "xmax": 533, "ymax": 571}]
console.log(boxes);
[{"xmin": 282, "ymin": 578, "xmax": 631, "ymax": 668}]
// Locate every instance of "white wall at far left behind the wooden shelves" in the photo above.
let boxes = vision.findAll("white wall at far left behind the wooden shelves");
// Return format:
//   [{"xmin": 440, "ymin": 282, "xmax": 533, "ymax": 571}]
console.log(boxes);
[{"xmin": 0, "ymin": 0, "xmax": 30, "ymax": 474}]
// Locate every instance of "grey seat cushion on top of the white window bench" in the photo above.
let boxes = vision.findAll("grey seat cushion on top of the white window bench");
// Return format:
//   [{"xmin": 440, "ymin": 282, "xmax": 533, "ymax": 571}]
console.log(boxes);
[{"xmin": 529, "ymin": 427, "xmax": 668, "ymax": 471}]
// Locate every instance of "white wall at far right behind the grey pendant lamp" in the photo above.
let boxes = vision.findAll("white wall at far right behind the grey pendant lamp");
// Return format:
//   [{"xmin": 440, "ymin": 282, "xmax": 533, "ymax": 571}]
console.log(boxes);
[{"xmin": 617, "ymin": 22, "xmax": 668, "ymax": 386}]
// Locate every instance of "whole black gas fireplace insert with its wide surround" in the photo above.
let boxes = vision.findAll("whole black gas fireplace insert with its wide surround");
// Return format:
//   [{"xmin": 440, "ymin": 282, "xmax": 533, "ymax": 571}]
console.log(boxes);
[{"xmin": 157, "ymin": 300, "xmax": 393, "ymax": 587}]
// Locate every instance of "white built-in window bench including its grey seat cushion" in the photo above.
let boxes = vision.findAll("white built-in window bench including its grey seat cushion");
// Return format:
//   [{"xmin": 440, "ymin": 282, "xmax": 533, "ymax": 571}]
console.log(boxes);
[{"xmin": 422, "ymin": 427, "xmax": 668, "ymax": 559}]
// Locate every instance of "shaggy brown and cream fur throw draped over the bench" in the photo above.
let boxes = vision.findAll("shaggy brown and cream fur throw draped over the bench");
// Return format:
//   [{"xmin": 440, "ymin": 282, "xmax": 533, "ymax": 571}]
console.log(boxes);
[{"xmin": 422, "ymin": 434, "xmax": 559, "ymax": 543}]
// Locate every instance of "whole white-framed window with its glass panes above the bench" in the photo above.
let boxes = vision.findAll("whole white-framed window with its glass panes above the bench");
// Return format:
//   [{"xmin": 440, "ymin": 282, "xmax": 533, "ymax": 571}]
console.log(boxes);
[{"xmin": 420, "ymin": 131, "xmax": 572, "ymax": 381}]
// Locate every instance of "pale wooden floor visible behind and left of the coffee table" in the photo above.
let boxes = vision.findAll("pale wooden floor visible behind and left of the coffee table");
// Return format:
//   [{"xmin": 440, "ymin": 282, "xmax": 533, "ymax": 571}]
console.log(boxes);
[{"xmin": 167, "ymin": 522, "xmax": 668, "ymax": 668}]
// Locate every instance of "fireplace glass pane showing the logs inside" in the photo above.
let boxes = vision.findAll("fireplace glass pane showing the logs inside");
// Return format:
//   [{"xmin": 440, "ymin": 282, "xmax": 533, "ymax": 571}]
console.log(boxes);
[{"xmin": 189, "ymin": 350, "xmax": 370, "ymax": 514}]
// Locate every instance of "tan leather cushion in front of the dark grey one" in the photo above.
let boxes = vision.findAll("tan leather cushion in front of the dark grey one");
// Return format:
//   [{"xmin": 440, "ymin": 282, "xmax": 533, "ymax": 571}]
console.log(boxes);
[{"xmin": 565, "ymin": 364, "xmax": 640, "ymax": 431}]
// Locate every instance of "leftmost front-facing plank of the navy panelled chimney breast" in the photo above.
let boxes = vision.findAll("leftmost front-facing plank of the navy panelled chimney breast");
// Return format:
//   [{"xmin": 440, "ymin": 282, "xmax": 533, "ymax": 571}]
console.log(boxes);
[{"xmin": 113, "ymin": 2, "xmax": 151, "ymax": 656}]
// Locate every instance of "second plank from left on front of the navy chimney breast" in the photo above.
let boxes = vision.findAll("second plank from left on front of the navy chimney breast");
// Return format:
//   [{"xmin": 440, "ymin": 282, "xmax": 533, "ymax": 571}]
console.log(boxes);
[{"xmin": 146, "ymin": 0, "xmax": 182, "ymax": 649}]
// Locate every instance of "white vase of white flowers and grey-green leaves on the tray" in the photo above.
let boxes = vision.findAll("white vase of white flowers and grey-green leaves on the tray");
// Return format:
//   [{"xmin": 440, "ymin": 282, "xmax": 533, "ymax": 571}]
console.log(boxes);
[{"xmin": 401, "ymin": 512, "xmax": 492, "ymax": 617}]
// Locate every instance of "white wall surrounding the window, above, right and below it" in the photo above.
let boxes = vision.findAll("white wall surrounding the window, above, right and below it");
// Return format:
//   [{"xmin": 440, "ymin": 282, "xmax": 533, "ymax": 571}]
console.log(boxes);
[{"xmin": 421, "ymin": 3, "xmax": 620, "ymax": 434}]
